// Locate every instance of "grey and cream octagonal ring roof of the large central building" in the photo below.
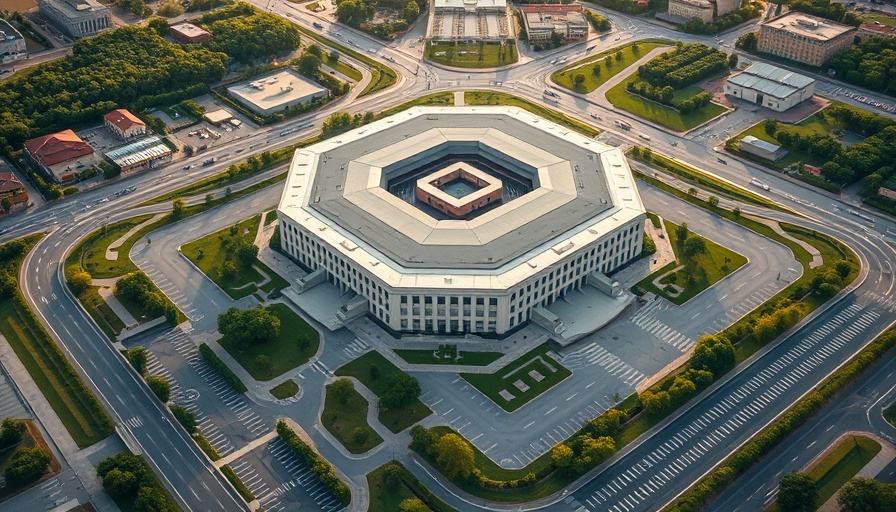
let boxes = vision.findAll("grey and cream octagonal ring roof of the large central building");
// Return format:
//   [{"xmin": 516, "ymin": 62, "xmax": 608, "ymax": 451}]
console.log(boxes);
[{"xmin": 278, "ymin": 107, "xmax": 643, "ymax": 288}]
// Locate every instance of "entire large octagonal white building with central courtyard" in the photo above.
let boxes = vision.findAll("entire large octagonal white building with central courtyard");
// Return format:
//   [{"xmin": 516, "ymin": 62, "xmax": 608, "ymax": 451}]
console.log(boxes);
[{"xmin": 278, "ymin": 107, "xmax": 644, "ymax": 336}]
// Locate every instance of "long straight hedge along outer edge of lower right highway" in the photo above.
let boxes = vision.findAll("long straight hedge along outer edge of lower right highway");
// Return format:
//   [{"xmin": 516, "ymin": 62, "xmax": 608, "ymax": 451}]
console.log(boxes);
[{"xmin": 667, "ymin": 330, "xmax": 896, "ymax": 512}]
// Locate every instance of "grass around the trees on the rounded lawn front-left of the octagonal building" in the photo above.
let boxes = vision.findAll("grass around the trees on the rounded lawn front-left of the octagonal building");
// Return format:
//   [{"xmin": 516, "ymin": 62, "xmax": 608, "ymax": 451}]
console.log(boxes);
[{"xmin": 218, "ymin": 304, "xmax": 320, "ymax": 381}]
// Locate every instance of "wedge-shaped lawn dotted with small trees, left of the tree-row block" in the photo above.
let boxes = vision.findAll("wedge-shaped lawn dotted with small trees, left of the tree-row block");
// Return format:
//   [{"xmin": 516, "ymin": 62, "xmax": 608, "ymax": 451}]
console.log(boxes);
[{"xmin": 551, "ymin": 40, "xmax": 672, "ymax": 94}]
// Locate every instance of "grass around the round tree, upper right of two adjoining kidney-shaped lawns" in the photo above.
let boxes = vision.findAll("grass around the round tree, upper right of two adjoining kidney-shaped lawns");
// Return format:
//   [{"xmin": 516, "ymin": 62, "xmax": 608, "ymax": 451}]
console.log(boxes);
[{"xmin": 336, "ymin": 350, "xmax": 432, "ymax": 434}]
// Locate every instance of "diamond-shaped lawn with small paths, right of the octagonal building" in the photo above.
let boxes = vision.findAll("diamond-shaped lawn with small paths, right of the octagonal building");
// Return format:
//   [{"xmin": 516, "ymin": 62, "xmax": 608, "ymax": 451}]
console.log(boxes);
[{"xmin": 637, "ymin": 219, "xmax": 747, "ymax": 306}]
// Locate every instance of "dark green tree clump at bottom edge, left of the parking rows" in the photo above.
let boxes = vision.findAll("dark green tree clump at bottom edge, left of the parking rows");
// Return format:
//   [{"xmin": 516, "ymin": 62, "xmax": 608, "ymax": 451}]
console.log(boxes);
[{"xmin": 96, "ymin": 452, "xmax": 180, "ymax": 512}]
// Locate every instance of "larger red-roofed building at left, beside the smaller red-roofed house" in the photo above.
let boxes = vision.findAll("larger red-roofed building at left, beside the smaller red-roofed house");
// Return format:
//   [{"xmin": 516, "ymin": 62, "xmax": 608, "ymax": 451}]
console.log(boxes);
[{"xmin": 25, "ymin": 130, "xmax": 96, "ymax": 183}]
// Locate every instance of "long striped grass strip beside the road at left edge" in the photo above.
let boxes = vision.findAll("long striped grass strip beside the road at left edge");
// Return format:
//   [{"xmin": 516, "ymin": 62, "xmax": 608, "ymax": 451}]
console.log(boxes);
[{"xmin": 0, "ymin": 234, "xmax": 113, "ymax": 448}]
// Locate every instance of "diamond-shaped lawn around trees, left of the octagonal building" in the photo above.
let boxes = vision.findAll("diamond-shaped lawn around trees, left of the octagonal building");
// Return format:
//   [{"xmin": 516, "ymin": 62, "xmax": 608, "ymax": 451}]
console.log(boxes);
[{"xmin": 181, "ymin": 214, "xmax": 289, "ymax": 300}]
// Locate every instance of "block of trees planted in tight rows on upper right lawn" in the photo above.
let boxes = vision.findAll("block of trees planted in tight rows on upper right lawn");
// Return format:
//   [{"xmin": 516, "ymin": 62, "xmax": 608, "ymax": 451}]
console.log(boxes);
[{"xmin": 638, "ymin": 42, "xmax": 728, "ymax": 89}]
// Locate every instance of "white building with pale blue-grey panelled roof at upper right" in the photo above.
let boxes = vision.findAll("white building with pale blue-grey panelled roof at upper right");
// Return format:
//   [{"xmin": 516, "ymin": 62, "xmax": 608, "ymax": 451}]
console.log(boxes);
[{"xmin": 725, "ymin": 62, "xmax": 815, "ymax": 112}]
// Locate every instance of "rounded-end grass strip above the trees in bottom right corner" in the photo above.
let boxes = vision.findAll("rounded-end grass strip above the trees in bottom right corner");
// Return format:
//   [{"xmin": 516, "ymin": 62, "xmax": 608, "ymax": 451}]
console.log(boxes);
[{"xmin": 808, "ymin": 436, "xmax": 881, "ymax": 507}]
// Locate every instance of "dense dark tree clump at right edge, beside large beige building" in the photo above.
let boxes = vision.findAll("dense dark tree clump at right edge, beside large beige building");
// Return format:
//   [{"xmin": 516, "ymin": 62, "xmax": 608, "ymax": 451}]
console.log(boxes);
[{"xmin": 824, "ymin": 35, "xmax": 896, "ymax": 96}]
